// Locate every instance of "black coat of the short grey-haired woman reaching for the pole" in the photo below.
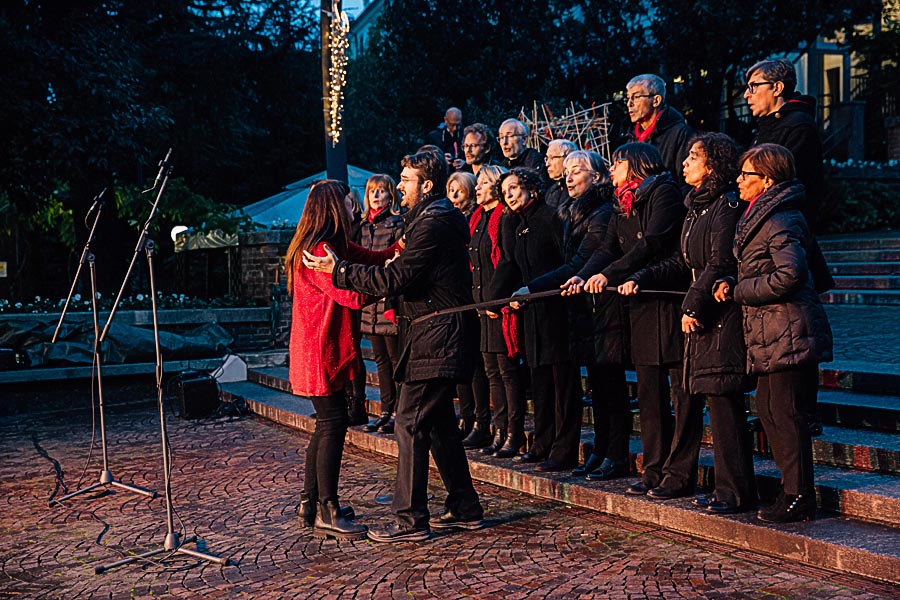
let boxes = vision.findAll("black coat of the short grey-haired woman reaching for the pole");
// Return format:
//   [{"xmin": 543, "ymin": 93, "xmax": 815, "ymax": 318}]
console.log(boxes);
[{"xmin": 528, "ymin": 185, "xmax": 631, "ymax": 365}]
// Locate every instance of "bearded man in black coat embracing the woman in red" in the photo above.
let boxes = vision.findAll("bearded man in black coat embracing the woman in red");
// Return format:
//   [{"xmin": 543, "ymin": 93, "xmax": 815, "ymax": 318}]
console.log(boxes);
[{"xmin": 304, "ymin": 152, "xmax": 484, "ymax": 542}]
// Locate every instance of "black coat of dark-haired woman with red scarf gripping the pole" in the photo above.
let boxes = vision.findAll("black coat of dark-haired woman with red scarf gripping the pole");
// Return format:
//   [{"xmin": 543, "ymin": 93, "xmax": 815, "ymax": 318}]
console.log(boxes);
[{"xmin": 578, "ymin": 173, "xmax": 687, "ymax": 365}]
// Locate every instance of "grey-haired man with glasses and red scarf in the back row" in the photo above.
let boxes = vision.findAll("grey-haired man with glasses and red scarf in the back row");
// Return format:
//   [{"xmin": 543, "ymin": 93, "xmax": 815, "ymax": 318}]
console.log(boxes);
[{"xmin": 624, "ymin": 73, "xmax": 694, "ymax": 191}]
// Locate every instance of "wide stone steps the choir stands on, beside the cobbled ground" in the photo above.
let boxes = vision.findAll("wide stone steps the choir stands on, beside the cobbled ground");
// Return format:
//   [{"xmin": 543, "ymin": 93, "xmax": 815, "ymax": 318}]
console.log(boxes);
[{"xmin": 222, "ymin": 332, "xmax": 900, "ymax": 584}]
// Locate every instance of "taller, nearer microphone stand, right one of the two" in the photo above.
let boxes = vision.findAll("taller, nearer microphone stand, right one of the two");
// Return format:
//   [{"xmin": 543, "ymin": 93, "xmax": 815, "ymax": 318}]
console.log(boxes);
[{"xmin": 94, "ymin": 148, "xmax": 228, "ymax": 575}]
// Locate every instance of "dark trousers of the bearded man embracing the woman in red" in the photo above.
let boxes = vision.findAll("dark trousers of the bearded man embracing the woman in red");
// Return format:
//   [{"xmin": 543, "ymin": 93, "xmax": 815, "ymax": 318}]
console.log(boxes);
[{"xmin": 392, "ymin": 379, "xmax": 484, "ymax": 528}]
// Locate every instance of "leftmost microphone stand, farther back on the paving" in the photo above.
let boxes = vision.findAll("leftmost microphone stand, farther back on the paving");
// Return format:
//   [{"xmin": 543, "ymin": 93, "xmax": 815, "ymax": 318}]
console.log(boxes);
[{"xmin": 50, "ymin": 188, "xmax": 156, "ymax": 506}]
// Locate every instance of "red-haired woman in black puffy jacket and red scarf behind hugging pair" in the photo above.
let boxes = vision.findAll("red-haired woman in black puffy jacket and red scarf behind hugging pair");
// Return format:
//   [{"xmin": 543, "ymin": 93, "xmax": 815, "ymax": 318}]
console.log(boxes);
[{"xmin": 359, "ymin": 175, "xmax": 405, "ymax": 433}]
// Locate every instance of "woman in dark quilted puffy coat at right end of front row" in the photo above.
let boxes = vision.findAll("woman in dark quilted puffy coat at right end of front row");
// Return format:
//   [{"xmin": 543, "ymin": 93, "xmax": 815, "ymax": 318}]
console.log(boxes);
[{"xmin": 715, "ymin": 144, "xmax": 832, "ymax": 522}]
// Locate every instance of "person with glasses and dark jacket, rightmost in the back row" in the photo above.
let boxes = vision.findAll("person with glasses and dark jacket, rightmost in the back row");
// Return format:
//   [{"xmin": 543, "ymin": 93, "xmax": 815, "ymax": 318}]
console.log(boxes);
[{"xmin": 744, "ymin": 58, "xmax": 825, "ymax": 229}]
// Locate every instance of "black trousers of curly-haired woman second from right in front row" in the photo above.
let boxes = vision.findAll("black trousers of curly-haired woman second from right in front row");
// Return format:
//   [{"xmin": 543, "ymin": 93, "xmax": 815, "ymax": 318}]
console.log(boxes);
[{"xmin": 706, "ymin": 393, "xmax": 756, "ymax": 506}]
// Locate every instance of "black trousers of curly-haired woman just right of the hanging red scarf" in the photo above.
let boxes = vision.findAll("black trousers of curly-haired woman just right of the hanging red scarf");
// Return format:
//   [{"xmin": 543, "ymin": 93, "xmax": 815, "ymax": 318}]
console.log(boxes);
[{"xmin": 531, "ymin": 361, "xmax": 582, "ymax": 466}]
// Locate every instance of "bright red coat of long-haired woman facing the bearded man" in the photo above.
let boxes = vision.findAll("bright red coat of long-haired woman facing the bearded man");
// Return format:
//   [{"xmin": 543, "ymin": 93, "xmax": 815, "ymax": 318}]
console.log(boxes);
[{"xmin": 289, "ymin": 242, "xmax": 397, "ymax": 396}]
